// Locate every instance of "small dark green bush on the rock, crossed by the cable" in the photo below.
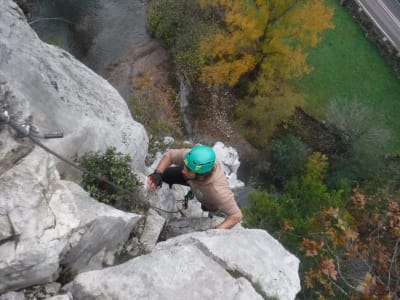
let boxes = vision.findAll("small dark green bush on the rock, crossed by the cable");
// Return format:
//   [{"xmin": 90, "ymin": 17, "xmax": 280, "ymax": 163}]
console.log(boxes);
[{"xmin": 79, "ymin": 147, "xmax": 141, "ymax": 211}]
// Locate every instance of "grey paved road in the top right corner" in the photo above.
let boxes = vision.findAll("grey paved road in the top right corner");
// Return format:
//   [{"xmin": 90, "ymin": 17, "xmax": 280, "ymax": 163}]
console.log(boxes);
[{"xmin": 356, "ymin": 0, "xmax": 400, "ymax": 51}]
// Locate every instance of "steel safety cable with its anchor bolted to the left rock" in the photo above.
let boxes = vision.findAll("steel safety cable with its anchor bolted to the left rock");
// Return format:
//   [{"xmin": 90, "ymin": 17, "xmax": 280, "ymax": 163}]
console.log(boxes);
[{"xmin": 0, "ymin": 111, "xmax": 184, "ymax": 215}]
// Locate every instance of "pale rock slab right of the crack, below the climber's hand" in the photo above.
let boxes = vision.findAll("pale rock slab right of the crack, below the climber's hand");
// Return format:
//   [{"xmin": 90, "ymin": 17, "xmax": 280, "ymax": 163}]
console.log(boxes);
[{"xmin": 154, "ymin": 228, "xmax": 301, "ymax": 299}]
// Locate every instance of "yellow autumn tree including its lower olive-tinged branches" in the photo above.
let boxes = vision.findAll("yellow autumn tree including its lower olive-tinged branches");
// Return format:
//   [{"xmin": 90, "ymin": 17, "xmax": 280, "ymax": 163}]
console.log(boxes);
[{"xmin": 199, "ymin": 0, "xmax": 333, "ymax": 148}]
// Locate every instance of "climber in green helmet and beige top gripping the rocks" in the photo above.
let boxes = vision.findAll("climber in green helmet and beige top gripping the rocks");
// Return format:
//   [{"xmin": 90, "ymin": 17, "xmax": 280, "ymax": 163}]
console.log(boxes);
[{"xmin": 148, "ymin": 145, "xmax": 243, "ymax": 229}]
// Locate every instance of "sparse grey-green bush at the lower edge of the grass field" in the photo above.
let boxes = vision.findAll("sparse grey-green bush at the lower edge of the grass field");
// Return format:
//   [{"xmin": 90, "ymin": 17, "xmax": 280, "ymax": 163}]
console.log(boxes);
[{"xmin": 327, "ymin": 98, "xmax": 392, "ymax": 185}]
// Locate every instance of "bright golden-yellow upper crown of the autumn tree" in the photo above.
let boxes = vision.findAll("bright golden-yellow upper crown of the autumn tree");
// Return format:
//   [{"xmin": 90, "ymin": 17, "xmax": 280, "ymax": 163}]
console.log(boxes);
[{"xmin": 199, "ymin": 0, "xmax": 334, "ymax": 91}]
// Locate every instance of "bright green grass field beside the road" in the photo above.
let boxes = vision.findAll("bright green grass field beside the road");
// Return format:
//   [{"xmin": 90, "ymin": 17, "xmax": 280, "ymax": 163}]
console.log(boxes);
[{"xmin": 295, "ymin": 0, "xmax": 400, "ymax": 152}]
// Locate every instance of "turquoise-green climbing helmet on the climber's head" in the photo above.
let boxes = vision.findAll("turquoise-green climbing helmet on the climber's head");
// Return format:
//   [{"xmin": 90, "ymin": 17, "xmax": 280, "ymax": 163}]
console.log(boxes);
[{"xmin": 184, "ymin": 145, "xmax": 215, "ymax": 174}]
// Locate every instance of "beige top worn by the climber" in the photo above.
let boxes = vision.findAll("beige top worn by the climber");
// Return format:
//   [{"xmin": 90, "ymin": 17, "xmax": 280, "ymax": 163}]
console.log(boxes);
[{"xmin": 165, "ymin": 149, "xmax": 240, "ymax": 216}]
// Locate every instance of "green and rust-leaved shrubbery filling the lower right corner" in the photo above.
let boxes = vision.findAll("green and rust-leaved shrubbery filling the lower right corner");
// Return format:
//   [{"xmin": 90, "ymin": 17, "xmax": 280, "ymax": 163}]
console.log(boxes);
[{"xmin": 244, "ymin": 153, "xmax": 400, "ymax": 300}]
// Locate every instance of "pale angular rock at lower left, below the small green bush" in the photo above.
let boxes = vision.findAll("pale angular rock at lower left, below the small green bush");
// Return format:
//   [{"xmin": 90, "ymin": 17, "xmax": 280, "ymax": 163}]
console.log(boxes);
[{"xmin": 0, "ymin": 148, "xmax": 141, "ymax": 293}]
